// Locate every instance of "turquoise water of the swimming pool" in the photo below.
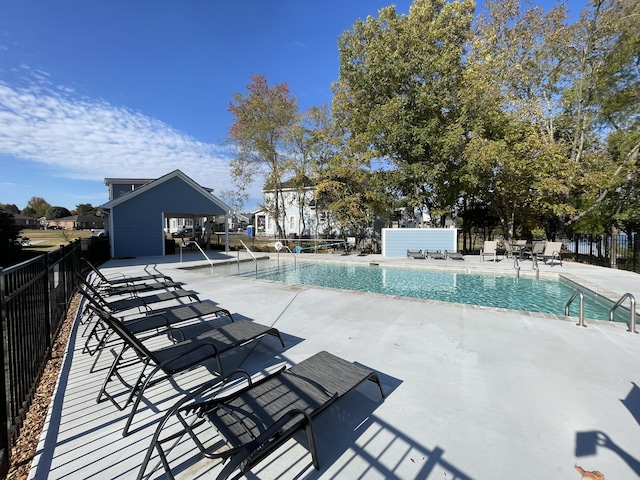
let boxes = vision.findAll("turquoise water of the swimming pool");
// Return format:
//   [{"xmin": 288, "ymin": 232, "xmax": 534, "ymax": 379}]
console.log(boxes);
[{"xmin": 236, "ymin": 262, "xmax": 628, "ymax": 322}]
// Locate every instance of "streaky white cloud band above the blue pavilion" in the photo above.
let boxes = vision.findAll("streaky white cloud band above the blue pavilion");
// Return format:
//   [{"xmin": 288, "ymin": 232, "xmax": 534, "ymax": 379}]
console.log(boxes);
[{"xmin": 0, "ymin": 71, "xmax": 261, "ymax": 200}]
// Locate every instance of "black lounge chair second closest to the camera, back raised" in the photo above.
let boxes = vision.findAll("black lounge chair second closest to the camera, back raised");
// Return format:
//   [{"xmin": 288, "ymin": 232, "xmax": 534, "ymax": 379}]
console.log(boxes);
[{"xmin": 89, "ymin": 307, "xmax": 284, "ymax": 436}]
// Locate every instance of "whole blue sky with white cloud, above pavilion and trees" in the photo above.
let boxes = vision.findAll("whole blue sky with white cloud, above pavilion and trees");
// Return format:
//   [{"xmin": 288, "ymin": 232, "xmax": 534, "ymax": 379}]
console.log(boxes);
[{"xmin": 0, "ymin": 0, "xmax": 583, "ymax": 211}]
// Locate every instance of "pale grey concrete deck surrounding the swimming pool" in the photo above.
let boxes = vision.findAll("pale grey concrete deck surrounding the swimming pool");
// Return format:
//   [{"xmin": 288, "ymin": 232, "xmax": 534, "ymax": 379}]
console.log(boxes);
[{"xmin": 29, "ymin": 252, "xmax": 640, "ymax": 480}]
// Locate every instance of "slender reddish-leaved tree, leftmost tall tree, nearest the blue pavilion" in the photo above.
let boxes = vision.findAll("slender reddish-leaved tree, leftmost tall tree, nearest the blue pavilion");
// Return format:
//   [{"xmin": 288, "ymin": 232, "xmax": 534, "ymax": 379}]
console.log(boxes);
[{"xmin": 229, "ymin": 75, "xmax": 297, "ymax": 238}]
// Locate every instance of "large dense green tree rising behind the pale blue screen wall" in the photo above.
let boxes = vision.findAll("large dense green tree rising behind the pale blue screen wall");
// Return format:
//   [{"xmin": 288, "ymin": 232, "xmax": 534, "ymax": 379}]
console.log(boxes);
[{"xmin": 333, "ymin": 0, "xmax": 474, "ymax": 227}]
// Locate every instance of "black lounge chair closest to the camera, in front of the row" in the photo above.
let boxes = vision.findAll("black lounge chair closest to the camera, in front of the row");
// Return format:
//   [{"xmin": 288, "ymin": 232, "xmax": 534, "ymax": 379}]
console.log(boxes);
[{"xmin": 138, "ymin": 352, "xmax": 384, "ymax": 480}]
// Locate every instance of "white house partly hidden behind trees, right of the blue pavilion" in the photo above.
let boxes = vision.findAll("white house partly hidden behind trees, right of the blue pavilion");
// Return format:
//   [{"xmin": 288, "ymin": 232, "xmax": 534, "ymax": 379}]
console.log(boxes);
[{"xmin": 254, "ymin": 182, "xmax": 338, "ymax": 238}]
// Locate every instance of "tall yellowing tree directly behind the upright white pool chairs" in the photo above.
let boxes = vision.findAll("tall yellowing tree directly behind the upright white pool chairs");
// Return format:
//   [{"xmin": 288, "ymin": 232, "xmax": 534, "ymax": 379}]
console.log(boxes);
[{"xmin": 463, "ymin": 0, "xmax": 574, "ymax": 239}]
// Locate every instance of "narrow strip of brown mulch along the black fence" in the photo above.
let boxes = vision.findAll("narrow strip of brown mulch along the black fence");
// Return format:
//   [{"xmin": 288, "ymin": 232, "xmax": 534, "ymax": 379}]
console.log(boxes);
[{"xmin": 7, "ymin": 295, "xmax": 80, "ymax": 480}]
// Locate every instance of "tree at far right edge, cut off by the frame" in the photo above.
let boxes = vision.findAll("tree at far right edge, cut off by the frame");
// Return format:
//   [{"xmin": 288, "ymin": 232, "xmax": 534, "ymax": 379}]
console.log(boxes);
[{"xmin": 564, "ymin": 0, "xmax": 640, "ymax": 237}]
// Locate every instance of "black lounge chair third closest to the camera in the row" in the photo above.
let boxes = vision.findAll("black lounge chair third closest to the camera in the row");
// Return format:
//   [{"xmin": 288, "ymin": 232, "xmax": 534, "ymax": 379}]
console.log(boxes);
[{"xmin": 82, "ymin": 301, "xmax": 234, "ymax": 373}]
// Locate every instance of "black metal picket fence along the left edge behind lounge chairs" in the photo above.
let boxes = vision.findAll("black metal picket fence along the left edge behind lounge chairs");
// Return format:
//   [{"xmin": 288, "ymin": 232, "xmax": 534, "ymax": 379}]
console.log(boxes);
[{"xmin": 0, "ymin": 238, "xmax": 109, "ymax": 478}]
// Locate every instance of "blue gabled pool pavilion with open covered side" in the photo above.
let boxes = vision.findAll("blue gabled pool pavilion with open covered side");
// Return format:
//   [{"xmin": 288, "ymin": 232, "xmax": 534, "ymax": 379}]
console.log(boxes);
[{"xmin": 100, "ymin": 170, "xmax": 231, "ymax": 258}]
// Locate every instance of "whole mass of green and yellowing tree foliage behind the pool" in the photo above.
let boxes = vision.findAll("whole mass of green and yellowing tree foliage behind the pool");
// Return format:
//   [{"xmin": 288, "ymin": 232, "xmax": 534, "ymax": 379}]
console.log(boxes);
[{"xmin": 224, "ymin": 0, "xmax": 640, "ymax": 238}]
